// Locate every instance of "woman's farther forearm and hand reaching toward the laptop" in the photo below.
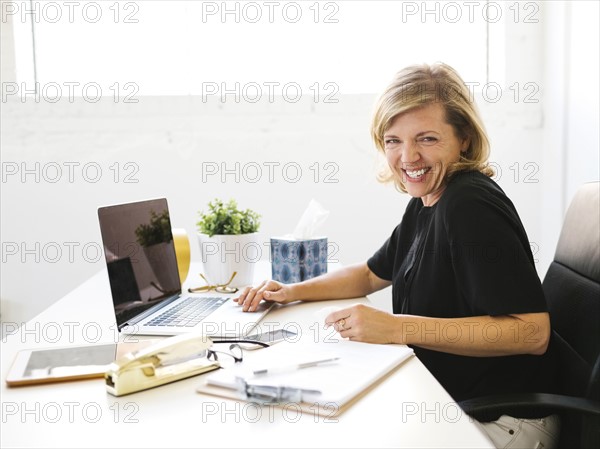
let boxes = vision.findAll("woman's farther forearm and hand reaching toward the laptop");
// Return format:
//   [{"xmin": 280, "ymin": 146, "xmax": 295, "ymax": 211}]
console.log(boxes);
[{"xmin": 234, "ymin": 263, "xmax": 391, "ymax": 312}]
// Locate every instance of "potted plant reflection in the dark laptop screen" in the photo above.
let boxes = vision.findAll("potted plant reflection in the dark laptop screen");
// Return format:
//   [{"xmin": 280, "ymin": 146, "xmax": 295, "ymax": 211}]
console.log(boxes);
[{"xmin": 135, "ymin": 210, "xmax": 179, "ymax": 293}]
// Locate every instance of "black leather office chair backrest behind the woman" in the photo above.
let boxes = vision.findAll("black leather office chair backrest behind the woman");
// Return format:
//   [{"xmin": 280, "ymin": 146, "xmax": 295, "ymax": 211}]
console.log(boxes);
[{"xmin": 543, "ymin": 182, "xmax": 600, "ymax": 445}]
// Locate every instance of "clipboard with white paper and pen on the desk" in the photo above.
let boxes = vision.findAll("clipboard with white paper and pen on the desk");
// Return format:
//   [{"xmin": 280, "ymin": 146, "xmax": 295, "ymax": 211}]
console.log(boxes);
[{"xmin": 196, "ymin": 340, "xmax": 414, "ymax": 417}]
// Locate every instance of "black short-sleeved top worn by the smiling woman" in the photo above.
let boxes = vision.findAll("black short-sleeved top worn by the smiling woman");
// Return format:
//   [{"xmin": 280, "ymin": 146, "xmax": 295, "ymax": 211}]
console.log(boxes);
[{"xmin": 367, "ymin": 172, "xmax": 554, "ymax": 401}]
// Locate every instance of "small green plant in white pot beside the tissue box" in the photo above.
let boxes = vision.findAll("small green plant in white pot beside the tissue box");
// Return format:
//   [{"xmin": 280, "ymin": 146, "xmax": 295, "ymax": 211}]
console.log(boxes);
[{"xmin": 197, "ymin": 199, "xmax": 261, "ymax": 287}]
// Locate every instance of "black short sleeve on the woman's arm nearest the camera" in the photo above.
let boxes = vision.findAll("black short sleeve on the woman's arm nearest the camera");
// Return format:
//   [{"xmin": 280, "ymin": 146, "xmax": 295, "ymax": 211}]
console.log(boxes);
[{"xmin": 443, "ymin": 190, "xmax": 547, "ymax": 315}]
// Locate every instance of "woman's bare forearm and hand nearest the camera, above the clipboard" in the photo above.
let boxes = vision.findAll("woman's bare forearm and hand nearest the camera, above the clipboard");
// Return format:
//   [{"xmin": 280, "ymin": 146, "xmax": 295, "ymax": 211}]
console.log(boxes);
[{"xmin": 325, "ymin": 305, "xmax": 550, "ymax": 357}]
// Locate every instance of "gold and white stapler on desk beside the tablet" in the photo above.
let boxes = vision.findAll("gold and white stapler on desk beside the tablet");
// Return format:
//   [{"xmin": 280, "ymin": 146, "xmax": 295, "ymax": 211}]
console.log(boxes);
[{"xmin": 104, "ymin": 333, "xmax": 219, "ymax": 396}]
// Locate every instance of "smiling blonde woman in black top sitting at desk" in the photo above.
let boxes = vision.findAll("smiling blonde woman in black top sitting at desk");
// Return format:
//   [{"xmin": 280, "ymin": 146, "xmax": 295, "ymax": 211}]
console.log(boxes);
[{"xmin": 237, "ymin": 64, "xmax": 558, "ymax": 447}]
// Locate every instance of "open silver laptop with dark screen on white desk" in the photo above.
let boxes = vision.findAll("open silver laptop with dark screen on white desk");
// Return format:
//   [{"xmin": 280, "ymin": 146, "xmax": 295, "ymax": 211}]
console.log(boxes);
[{"xmin": 98, "ymin": 198, "xmax": 273, "ymax": 338}]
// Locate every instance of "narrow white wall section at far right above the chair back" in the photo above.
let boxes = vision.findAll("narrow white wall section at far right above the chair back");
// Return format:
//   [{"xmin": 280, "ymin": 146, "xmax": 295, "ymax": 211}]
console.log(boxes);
[{"xmin": 540, "ymin": 1, "xmax": 600, "ymax": 270}]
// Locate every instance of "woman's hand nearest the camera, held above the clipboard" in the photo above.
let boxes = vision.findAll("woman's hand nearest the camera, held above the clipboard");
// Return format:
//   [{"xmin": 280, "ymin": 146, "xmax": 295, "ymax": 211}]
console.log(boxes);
[{"xmin": 325, "ymin": 304, "xmax": 401, "ymax": 344}]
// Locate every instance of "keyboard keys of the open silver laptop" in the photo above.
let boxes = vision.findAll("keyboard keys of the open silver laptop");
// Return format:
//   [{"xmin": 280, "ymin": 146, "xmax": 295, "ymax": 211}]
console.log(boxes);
[{"xmin": 146, "ymin": 297, "xmax": 227, "ymax": 327}]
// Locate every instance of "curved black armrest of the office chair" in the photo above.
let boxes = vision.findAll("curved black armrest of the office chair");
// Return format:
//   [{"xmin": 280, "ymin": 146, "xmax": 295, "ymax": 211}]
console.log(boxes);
[{"xmin": 458, "ymin": 393, "xmax": 600, "ymax": 421}]
